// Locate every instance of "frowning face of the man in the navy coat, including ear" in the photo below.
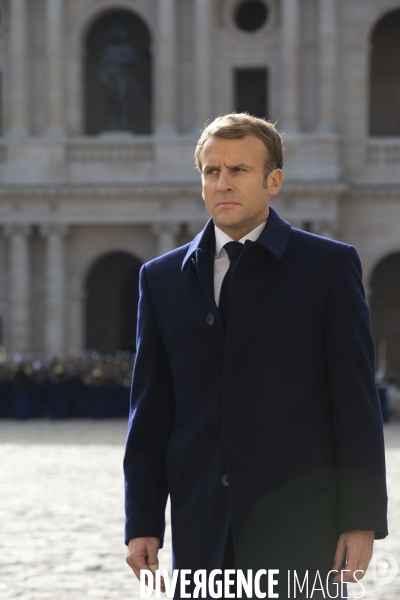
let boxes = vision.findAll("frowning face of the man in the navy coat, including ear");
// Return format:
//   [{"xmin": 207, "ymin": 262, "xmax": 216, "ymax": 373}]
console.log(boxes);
[{"xmin": 202, "ymin": 135, "xmax": 283, "ymax": 239}]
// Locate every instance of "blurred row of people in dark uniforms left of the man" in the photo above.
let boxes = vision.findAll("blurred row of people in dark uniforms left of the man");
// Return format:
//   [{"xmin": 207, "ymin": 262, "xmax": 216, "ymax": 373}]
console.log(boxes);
[{"xmin": 0, "ymin": 348, "xmax": 134, "ymax": 419}]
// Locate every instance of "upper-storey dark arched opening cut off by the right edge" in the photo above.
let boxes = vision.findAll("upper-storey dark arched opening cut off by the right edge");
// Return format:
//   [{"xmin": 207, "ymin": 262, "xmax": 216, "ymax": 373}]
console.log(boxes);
[{"xmin": 370, "ymin": 10, "xmax": 400, "ymax": 136}]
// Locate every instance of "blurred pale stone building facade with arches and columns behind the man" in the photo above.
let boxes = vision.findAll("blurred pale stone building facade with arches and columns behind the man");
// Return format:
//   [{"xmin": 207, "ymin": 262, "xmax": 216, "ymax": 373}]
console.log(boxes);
[{"xmin": 0, "ymin": 0, "xmax": 400, "ymax": 375}]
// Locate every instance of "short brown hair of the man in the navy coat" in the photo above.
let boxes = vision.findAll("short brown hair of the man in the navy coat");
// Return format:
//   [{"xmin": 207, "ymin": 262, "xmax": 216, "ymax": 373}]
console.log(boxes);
[{"xmin": 194, "ymin": 113, "xmax": 283, "ymax": 177}]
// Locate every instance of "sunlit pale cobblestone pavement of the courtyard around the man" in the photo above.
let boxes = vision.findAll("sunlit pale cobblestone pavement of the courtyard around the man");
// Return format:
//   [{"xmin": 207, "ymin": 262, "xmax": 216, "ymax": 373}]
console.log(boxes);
[{"xmin": 0, "ymin": 421, "xmax": 400, "ymax": 600}]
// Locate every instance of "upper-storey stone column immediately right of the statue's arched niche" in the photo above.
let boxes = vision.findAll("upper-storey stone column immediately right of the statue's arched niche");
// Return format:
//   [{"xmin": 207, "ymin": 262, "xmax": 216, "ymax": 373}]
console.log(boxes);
[{"xmin": 155, "ymin": 0, "xmax": 176, "ymax": 135}]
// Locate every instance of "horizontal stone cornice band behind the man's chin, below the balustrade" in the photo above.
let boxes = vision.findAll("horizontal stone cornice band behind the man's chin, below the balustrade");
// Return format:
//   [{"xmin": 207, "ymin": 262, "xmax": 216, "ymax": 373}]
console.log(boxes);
[{"xmin": 0, "ymin": 181, "xmax": 400, "ymax": 224}]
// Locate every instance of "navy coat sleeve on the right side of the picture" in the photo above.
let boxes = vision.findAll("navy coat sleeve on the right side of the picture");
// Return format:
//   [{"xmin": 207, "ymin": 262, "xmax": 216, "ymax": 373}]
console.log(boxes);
[{"xmin": 325, "ymin": 246, "xmax": 388, "ymax": 539}]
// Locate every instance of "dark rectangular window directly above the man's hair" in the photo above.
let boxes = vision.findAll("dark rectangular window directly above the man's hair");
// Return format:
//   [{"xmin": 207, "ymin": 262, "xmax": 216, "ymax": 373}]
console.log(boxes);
[{"xmin": 235, "ymin": 69, "xmax": 268, "ymax": 119}]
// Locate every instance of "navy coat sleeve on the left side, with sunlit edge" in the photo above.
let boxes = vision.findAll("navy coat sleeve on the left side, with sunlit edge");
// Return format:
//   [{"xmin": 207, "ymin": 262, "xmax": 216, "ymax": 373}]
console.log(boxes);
[{"xmin": 123, "ymin": 265, "xmax": 174, "ymax": 547}]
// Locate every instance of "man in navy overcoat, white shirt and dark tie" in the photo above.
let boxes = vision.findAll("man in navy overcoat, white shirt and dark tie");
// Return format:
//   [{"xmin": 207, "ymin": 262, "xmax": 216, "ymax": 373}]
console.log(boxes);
[{"xmin": 124, "ymin": 114, "xmax": 387, "ymax": 598}]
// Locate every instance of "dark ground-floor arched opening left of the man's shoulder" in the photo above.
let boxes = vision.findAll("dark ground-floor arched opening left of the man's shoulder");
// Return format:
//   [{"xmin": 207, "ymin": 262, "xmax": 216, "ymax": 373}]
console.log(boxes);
[{"xmin": 86, "ymin": 252, "xmax": 142, "ymax": 354}]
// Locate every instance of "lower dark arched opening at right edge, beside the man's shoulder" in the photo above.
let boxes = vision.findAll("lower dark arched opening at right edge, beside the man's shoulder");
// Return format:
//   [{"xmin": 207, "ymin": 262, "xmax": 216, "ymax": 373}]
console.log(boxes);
[{"xmin": 371, "ymin": 252, "xmax": 400, "ymax": 382}]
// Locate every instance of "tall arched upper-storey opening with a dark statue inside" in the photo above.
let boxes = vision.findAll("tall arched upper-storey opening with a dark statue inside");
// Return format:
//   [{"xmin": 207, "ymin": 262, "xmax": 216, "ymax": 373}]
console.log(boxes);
[{"xmin": 85, "ymin": 9, "xmax": 152, "ymax": 135}]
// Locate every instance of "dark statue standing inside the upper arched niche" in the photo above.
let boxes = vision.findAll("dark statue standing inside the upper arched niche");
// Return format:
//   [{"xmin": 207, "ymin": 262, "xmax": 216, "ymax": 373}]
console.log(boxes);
[{"xmin": 100, "ymin": 21, "xmax": 136, "ymax": 131}]
